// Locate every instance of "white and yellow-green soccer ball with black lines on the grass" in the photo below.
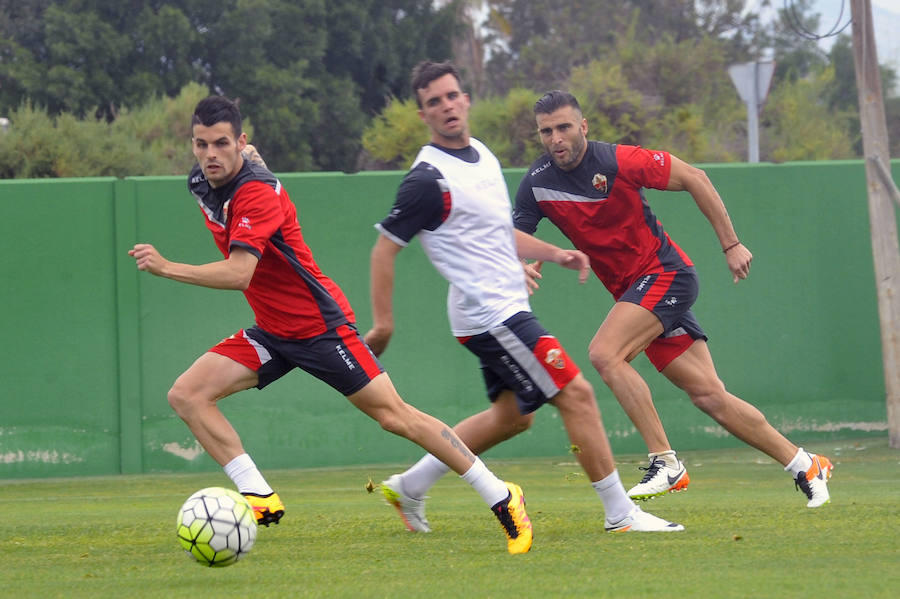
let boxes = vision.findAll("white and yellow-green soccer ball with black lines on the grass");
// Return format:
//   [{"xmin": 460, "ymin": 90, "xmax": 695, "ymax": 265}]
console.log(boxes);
[{"xmin": 175, "ymin": 487, "xmax": 256, "ymax": 567}]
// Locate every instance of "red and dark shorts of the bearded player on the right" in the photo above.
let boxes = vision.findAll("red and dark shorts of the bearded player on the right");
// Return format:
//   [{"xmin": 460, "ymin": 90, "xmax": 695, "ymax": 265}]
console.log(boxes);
[{"xmin": 617, "ymin": 266, "xmax": 707, "ymax": 371}]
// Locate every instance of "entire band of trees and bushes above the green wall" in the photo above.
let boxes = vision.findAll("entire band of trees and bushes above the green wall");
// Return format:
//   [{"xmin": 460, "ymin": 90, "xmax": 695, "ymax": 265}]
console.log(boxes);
[{"xmin": 0, "ymin": 0, "xmax": 900, "ymax": 176}]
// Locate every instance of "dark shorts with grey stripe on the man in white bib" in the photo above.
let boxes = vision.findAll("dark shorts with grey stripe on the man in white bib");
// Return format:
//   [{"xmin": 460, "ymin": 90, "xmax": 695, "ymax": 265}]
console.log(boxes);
[{"xmin": 457, "ymin": 312, "xmax": 581, "ymax": 414}]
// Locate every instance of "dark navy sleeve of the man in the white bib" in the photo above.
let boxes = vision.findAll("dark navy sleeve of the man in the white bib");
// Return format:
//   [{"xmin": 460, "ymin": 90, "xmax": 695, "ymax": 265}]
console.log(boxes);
[{"xmin": 375, "ymin": 162, "xmax": 446, "ymax": 246}]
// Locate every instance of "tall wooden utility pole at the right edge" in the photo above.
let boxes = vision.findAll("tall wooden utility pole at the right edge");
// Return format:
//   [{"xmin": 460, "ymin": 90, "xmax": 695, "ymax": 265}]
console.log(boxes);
[{"xmin": 850, "ymin": 0, "xmax": 900, "ymax": 449}]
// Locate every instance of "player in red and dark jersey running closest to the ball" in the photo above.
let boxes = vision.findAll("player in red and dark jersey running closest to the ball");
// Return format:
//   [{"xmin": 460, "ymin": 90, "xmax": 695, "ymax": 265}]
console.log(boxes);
[{"xmin": 128, "ymin": 96, "xmax": 530, "ymax": 546}]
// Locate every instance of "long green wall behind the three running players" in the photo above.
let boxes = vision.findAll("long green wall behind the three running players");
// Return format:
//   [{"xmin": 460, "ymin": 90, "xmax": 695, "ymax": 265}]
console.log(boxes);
[{"xmin": 0, "ymin": 161, "xmax": 898, "ymax": 478}]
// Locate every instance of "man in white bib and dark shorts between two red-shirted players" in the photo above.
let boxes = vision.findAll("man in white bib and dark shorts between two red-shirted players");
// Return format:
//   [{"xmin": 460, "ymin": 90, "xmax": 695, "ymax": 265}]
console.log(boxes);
[{"xmin": 365, "ymin": 62, "xmax": 684, "ymax": 550}]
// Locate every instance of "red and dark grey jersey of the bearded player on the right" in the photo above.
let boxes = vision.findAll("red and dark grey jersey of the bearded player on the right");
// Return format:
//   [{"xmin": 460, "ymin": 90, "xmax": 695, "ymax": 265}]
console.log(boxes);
[{"xmin": 513, "ymin": 141, "xmax": 693, "ymax": 300}]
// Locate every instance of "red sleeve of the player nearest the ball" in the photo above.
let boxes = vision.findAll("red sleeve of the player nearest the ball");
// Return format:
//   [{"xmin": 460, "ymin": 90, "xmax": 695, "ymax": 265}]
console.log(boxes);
[{"xmin": 228, "ymin": 181, "xmax": 284, "ymax": 258}]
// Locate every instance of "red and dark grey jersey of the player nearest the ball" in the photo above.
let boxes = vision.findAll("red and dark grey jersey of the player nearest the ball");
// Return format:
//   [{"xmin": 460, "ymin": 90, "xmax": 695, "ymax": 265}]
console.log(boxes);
[{"xmin": 188, "ymin": 160, "xmax": 354, "ymax": 339}]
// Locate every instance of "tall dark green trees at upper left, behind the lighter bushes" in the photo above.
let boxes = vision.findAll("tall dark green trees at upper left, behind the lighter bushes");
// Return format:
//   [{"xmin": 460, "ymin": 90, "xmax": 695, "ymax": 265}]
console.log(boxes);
[{"xmin": 0, "ymin": 0, "xmax": 455, "ymax": 174}]
